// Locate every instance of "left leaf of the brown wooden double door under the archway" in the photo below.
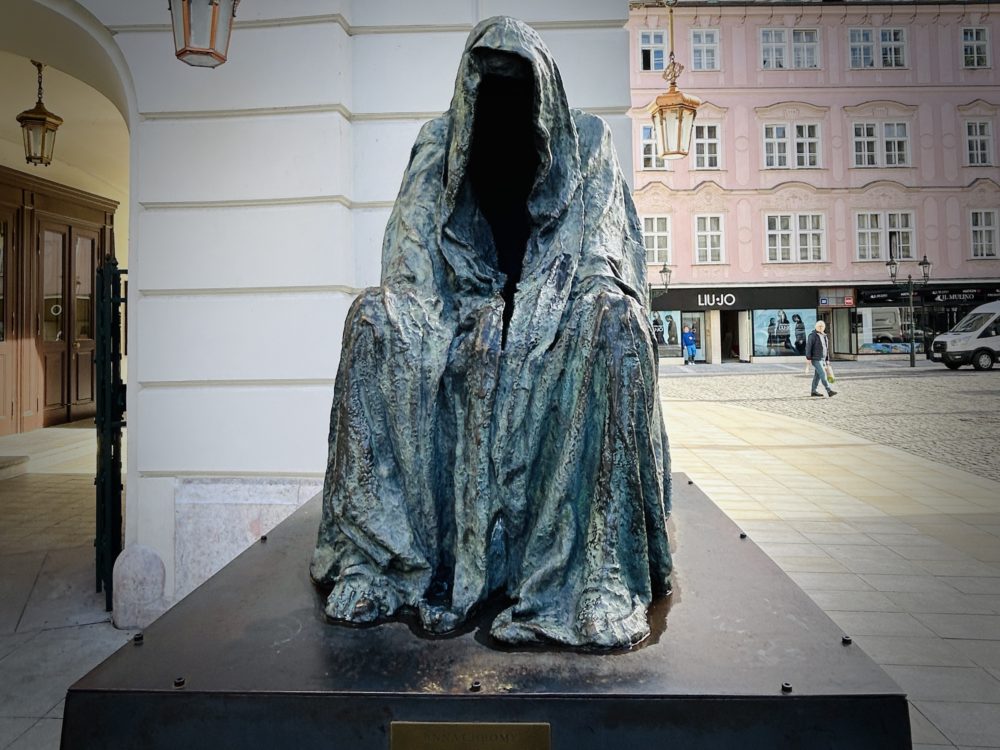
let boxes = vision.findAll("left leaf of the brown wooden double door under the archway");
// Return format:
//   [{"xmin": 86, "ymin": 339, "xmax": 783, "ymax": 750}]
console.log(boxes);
[{"xmin": 35, "ymin": 222, "xmax": 72, "ymax": 427}]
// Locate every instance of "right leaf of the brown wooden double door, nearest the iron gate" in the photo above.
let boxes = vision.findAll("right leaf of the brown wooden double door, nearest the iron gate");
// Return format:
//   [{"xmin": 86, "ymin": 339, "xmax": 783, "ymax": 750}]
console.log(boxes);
[{"xmin": 67, "ymin": 227, "xmax": 99, "ymax": 420}]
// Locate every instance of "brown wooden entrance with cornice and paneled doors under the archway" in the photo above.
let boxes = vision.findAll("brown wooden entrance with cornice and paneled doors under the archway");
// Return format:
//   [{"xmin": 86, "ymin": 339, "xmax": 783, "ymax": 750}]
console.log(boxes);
[{"xmin": 0, "ymin": 167, "xmax": 117, "ymax": 434}]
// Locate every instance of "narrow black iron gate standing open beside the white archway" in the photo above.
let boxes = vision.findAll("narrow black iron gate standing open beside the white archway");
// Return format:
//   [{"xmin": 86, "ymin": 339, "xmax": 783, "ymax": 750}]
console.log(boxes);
[{"xmin": 94, "ymin": 255, "xmax": 128, "ymax": 612}]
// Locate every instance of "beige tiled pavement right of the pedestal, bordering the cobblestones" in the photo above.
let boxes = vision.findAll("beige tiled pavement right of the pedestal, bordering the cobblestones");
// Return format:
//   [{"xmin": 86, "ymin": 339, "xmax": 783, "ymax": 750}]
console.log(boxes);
[{"xmin": 664, "ymin": 399, "xmax": 1000, "ymax": 748}]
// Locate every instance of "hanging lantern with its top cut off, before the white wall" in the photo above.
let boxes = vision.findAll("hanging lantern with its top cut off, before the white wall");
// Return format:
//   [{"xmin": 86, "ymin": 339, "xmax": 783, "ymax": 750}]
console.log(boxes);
[{"xmin": 167, "ymin": 0, "xmax": 240, "ymax": 68}]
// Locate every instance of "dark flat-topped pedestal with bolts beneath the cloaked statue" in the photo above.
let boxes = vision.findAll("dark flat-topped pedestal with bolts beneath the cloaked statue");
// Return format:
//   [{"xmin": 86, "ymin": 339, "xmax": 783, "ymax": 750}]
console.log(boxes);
[{"xmin": 62, "ymin": 475, "xmax": 910, "ymax": 750}]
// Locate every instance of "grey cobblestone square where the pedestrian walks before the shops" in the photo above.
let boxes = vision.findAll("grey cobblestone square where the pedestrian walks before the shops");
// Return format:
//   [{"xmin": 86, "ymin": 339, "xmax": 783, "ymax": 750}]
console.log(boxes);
[{"xmin": 660, "ymin": 362, "xmax": 1000, "ymax": 481}]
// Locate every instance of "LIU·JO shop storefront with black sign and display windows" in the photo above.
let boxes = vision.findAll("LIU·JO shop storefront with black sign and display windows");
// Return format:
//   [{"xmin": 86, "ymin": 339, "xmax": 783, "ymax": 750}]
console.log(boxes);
[{"xmin": 652, "ymin": 286, "xmax": 817, "ymax": 363}]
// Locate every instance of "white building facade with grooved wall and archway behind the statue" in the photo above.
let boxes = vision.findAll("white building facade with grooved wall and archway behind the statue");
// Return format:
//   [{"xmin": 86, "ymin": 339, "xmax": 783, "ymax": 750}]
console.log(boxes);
[{"xmin": 0, "ymin": 0, "xmax": 632, "ymax": 626}]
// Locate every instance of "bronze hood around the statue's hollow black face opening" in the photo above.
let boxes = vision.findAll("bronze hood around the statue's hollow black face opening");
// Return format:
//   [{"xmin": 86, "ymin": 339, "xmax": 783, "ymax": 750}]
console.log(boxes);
[{"xmin": 445, "ymin": 16, "xmax": 580, "ymax": 223}]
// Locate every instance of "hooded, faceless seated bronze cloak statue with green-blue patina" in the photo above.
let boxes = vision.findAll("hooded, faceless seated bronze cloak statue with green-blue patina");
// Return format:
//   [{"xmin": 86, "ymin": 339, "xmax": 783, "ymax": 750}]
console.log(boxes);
[{"xmin": 311, "ymin": 18, "xmax": 671, "ymax": 648}]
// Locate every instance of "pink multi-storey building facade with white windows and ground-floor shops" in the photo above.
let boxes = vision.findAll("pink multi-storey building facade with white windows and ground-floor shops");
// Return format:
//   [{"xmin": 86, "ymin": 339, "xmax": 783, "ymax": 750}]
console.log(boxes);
[{"xmin": 629, "ymin": 0, "xmax": 1000, "ymax": 362}]
